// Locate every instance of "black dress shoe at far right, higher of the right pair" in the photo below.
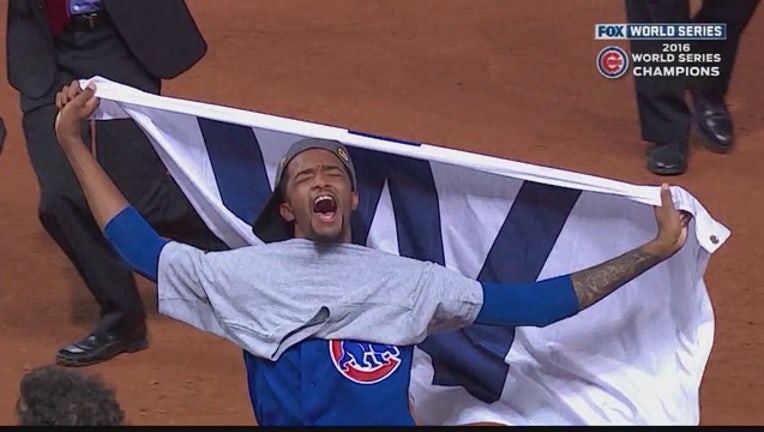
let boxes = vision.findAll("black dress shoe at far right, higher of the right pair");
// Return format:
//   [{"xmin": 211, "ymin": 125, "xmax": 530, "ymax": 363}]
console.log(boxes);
[{"xmin": 693, "ymin": 93, "xmax": 734, "ymax": 153}]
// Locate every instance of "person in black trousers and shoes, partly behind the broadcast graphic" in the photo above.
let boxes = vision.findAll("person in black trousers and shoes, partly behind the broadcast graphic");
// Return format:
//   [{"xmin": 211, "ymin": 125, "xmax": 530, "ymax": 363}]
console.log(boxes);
[{"xmin": 626, "ymin": 0, "xmax": 759, "ymax": 175}]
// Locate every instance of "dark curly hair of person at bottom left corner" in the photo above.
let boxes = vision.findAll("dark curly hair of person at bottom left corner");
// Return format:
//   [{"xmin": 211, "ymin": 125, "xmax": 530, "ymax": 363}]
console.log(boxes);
[{"xmin": 16, "ymin": 365, "xmax": 125, "ymax": 426}]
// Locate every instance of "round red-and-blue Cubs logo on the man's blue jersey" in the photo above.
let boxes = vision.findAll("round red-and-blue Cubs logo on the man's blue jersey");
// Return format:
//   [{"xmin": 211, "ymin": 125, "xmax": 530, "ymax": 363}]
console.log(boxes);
[{"xmin": 329, "ymin": 340, "xmax": 401, "ymax": 384}]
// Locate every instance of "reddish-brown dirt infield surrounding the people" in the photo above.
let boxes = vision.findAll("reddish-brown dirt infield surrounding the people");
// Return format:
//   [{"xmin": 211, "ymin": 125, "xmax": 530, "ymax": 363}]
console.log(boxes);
[{"xmin": 0, "ymin": 0, "xmax": 764, "ymax": 425}]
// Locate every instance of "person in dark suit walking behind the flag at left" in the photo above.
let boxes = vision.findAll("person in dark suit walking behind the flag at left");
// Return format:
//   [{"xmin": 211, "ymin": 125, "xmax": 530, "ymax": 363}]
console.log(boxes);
[{"xmin": 6, "ymin": 0, "xmax": 226, "ymax": 366}]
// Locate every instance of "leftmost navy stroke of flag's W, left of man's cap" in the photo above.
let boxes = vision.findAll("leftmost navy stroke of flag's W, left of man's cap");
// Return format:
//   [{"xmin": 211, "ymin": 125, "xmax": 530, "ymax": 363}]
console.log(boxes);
[{"xmin": 198, "ymin": 118, "xmax": 271, "ymax": 223}]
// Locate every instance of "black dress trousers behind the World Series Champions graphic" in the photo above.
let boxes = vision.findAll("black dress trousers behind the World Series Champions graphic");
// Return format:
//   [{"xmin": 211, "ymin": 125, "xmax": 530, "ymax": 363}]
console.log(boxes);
[{"xmin": 626, "ymin": 0, "xmax": 759, "ymax": 144}]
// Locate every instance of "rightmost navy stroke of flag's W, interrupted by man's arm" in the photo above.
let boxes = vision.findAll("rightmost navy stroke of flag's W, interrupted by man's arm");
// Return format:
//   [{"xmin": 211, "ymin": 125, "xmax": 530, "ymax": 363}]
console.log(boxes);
[{"xmin": 419, "ymin": 182, "xmax": 581, "ymax": 403}]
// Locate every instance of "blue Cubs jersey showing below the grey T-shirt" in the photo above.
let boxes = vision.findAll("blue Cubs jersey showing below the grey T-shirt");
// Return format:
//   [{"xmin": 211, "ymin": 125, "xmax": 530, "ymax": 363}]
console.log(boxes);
[{"xmin": 244, "ymin": 339, "xmax": 415, "ymax": 426}]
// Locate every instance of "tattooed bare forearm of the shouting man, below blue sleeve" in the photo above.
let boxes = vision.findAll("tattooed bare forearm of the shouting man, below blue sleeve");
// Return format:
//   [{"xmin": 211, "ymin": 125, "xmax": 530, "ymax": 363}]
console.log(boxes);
[{"xmin": 571, "ymin": 247, "xmax": 661, "ymax": 310}]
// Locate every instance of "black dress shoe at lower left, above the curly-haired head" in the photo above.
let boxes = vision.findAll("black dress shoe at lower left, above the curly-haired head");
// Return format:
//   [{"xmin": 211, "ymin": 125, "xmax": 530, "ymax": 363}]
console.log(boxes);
[{"xmin": 56, "ymin": 333, "xmax": 149, "ymax": 366}]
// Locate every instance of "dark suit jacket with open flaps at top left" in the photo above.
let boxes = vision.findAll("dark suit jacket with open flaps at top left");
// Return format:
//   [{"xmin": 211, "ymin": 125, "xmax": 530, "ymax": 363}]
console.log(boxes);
[{"xmin": 6, "ymin": 0, "xmax": 207, "ymax": 98}]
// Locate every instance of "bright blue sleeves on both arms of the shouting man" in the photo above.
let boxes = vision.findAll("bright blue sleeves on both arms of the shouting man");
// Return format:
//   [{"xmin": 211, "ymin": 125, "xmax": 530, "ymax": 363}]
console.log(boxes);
[{"xmin": 103, "ymin": 206, "xmax": 578, "ymax": 326}]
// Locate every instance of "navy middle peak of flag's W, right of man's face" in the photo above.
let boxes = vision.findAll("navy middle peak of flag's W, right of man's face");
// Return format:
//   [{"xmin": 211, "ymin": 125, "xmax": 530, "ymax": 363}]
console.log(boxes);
[{"xmin": 348, "ymin": 147, "xmax": 445, "ymax": 265}]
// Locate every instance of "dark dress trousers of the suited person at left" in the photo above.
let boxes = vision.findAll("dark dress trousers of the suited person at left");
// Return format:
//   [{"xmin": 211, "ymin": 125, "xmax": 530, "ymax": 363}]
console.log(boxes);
[{"xmin": 21, "ymin": 19, "xmax": 227, "ymax": 335}]
